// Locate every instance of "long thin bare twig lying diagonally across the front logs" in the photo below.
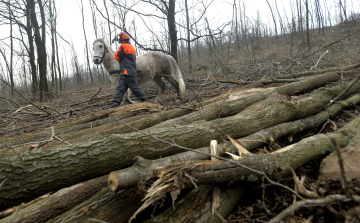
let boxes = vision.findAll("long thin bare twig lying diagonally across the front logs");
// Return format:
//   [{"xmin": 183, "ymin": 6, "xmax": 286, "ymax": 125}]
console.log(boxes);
[{"xmin": 116, "ymin": 118, "xmax": 304, "ymax": 199}]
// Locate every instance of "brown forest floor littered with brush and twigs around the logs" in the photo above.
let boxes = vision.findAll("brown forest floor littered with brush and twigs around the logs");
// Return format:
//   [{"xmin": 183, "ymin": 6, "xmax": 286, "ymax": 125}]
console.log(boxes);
[{"xmin": 0, "ymin": 22, "xmax": 360, "ymax": 222}]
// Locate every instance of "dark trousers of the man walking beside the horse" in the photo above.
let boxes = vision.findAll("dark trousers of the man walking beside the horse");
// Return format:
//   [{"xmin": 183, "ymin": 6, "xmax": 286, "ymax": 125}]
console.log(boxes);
[{"xmin": 111, "ymin": 75, "xmax": 150, "ymax": 107}]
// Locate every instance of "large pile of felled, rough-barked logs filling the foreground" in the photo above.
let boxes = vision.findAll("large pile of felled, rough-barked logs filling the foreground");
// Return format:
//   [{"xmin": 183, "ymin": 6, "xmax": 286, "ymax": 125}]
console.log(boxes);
[{"xmin": 0, "ymin": 65, "xmax": 360, "ymax": 223}]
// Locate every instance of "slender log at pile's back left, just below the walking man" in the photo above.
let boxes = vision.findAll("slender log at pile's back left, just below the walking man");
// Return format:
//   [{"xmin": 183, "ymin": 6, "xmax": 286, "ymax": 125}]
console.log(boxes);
[{"xmin": 0, "ymin": 103, "xmax": 183, "ymax": 150}]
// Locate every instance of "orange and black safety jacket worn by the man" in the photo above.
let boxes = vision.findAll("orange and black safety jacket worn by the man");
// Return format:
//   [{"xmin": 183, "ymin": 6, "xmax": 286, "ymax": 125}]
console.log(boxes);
[{"xmin": 115, "ymin": 43, "xmax": 137, "ymax": 76}]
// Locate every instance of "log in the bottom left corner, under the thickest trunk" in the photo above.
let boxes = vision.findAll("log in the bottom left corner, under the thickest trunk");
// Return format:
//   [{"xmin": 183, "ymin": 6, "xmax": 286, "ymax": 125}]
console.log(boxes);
[{"xmin": 0, "ymin": 176, "xmax": 107, "ymax": 223}]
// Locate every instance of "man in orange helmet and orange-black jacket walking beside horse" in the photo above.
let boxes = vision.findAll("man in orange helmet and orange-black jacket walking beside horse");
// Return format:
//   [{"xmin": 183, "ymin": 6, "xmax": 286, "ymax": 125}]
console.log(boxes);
[{"xmin": 104, "ymin": 32, "xmax": 150, "ymax": 109}]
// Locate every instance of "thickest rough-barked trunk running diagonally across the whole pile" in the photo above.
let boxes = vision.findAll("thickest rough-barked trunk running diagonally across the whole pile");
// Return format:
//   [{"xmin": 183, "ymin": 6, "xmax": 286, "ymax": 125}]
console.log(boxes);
[{"xmin": 0, "ymin": 78, "xmax": 360, "ymax": 209}]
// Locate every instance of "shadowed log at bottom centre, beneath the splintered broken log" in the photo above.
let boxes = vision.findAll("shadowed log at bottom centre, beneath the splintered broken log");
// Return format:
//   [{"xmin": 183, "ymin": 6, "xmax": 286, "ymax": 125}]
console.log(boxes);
[{"xmin": 146, "ymin": 185, "xmax": 245, "ymax": 223}]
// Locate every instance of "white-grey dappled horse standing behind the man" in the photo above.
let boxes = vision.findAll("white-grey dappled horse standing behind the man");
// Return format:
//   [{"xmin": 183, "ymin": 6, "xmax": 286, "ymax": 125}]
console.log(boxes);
[{"xmin": 93, "ymin": 38, "xmax": 185, "ymax": 103}]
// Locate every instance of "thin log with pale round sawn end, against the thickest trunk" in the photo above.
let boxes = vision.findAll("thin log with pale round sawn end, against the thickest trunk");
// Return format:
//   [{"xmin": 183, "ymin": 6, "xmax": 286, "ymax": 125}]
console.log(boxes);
[{"xmin": 108, "ymin": 95, "xmax": 360, "ymax": 191}]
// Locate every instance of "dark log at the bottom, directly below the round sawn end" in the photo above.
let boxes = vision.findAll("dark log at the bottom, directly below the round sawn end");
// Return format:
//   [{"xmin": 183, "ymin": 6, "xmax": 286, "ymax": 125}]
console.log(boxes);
[{"xmin": 47, "ymin": 188, "xmax": 141, "ymax": 223}]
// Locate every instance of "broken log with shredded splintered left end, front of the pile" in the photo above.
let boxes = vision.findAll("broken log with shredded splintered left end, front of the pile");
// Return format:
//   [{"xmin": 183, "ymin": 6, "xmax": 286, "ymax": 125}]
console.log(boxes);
[{"xmin": 143, "ymin": 115, "xmax": 360, "ymax": 195}]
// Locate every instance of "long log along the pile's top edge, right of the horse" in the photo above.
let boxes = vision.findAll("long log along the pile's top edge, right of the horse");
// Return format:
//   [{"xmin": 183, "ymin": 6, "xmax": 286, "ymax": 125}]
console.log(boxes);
[{"xmin": 152, "ymin": 72, "xmax": 340, "ymax": 128}]
